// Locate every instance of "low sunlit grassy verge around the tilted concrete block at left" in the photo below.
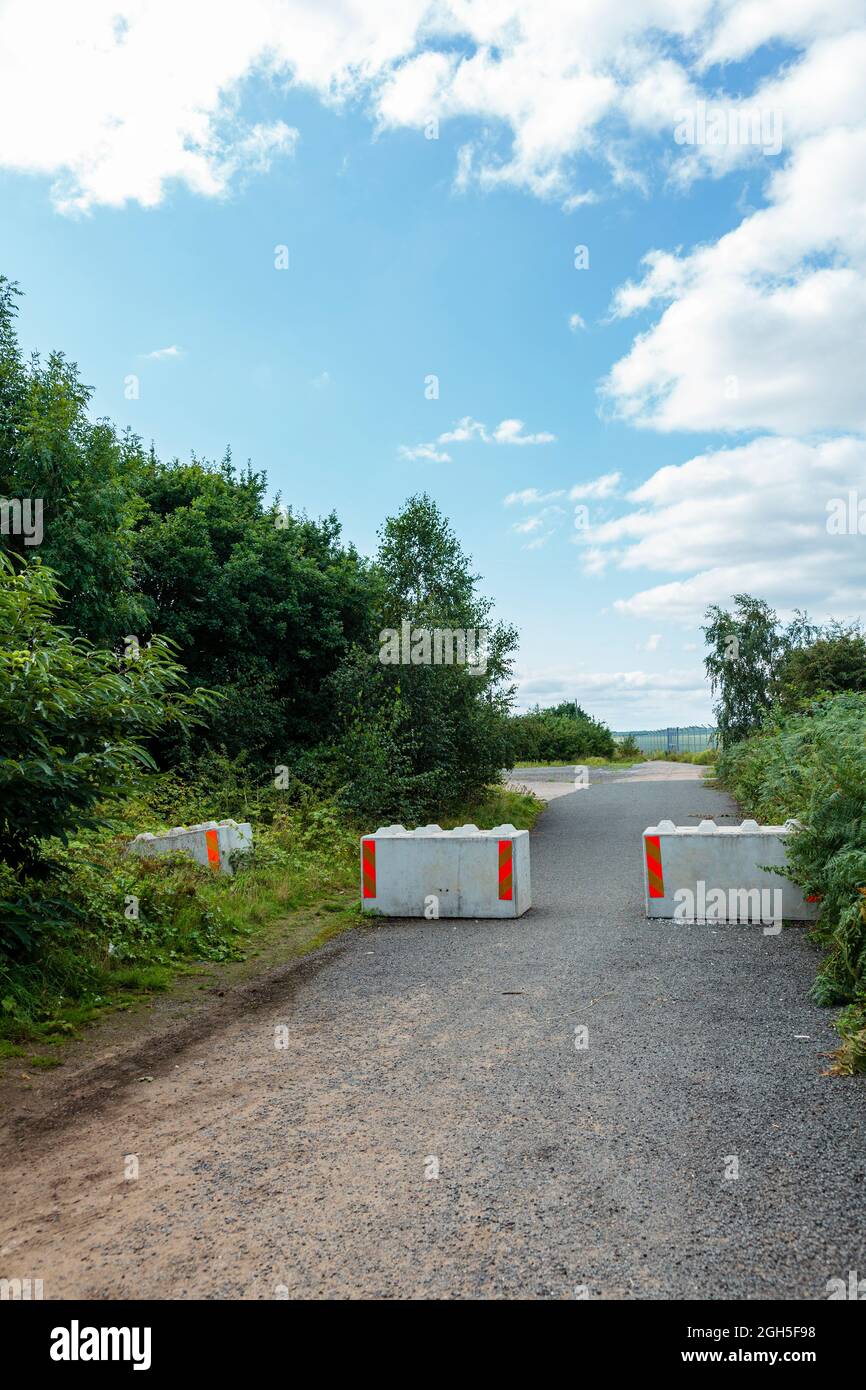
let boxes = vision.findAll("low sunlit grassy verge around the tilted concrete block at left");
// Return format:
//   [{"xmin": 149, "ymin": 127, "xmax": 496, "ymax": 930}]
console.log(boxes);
[{"xmin": 0, "ymin": 787, "xmax": 544, "ymax": 1050}]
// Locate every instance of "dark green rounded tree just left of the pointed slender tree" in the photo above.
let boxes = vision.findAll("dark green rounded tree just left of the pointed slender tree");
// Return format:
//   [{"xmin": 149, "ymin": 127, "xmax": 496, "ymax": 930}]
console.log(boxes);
[{"xmin": 135, "ymin": 455, "xmax": 373, "ymax": 769}]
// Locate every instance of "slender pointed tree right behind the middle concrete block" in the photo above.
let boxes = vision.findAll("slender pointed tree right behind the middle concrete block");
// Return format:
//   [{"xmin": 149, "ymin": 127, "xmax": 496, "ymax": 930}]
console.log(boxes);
[{"xmin": 327, "ymin": 496, "xmax": 517, "ymax": 821}]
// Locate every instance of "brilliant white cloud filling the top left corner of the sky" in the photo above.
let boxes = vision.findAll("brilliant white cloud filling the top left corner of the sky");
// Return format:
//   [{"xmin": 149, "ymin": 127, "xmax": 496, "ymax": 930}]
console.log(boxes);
[{"xmin": 0, "ymin": 0, "xmax": 308, "ymax": 211}]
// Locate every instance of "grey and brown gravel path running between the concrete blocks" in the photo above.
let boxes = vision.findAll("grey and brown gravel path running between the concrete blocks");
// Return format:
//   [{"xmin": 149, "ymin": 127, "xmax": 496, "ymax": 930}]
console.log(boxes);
[{"xmin": 0, "ymin": 778, "xmax": 866, "ymax": 1298}]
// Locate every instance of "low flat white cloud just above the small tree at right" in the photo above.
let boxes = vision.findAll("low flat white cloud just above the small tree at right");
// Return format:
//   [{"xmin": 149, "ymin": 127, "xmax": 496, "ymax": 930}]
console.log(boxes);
[{"xmin": 575, "ymin": 436, "xmax": 866, "ymax": 623}]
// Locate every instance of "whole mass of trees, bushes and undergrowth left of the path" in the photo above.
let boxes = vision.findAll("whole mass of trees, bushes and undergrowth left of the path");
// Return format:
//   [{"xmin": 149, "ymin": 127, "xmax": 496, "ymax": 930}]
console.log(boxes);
[{"xmin": 0, "ymin": 278, "xmax": 541, "ymax": 1045}]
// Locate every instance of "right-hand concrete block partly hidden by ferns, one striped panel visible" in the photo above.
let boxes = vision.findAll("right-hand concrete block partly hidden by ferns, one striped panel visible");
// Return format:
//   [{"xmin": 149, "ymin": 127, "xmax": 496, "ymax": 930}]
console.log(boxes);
[{"xmin": 644, "ymin": 820, "xmax": 819, "ymax": 927}]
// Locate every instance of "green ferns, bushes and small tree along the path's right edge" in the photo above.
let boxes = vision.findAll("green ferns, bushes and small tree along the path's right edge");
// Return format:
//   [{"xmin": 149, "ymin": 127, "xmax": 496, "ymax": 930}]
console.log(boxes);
[{"xmin": 705, "ymin": 595, "xmax": 866, "ymax": 1074}]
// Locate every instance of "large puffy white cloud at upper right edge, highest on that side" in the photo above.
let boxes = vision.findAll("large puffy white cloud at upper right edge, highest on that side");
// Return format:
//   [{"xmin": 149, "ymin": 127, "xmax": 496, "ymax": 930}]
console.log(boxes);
[{"xmin": 602, "ymin": 33, "xmax": 866, "ymax": 434}]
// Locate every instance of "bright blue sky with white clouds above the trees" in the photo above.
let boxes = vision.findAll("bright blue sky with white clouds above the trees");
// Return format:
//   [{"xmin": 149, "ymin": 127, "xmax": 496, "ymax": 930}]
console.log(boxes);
[{"xmin": 0, "ymin": 0, "xmax": 863, "ymax": 728}]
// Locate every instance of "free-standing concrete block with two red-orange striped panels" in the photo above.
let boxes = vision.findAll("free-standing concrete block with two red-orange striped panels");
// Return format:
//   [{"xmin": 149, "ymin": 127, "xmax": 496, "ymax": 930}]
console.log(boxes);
[{"xmin": 360, "ymin": 824, "xmax": 532, "ymax": 920}]
